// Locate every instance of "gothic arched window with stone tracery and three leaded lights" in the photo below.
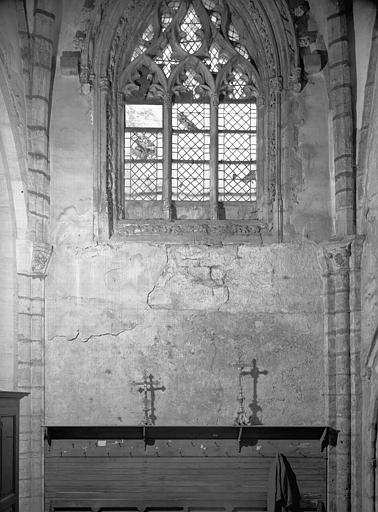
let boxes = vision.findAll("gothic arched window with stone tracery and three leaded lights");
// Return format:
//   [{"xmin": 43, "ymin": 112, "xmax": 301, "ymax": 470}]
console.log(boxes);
[{"xmin": 118, "ymin": 0, "xmax": 259, "ymax": 220}]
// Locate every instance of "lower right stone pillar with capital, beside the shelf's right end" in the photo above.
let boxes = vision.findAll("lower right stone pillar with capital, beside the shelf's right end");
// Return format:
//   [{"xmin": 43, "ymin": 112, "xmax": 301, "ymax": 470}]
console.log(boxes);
[{"xmin": 319, "ymin": 237, "xmax": 363, "ymax": 512}]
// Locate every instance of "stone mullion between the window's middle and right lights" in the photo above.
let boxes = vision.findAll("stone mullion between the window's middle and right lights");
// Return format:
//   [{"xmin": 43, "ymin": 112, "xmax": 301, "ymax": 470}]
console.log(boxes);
[{"xmin": 210, "ymin": 94, "xmax": 219, "ymax": 220}]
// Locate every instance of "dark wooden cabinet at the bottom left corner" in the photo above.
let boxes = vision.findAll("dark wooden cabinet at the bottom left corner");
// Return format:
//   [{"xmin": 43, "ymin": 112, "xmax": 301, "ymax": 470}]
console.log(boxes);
[{"xmin": 0, "ymin": 391, "xmax": 27, "ymax": 512}]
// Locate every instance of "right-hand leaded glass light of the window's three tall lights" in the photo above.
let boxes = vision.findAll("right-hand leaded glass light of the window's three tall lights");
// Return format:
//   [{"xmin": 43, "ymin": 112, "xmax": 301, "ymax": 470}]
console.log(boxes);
[{"xmin": 218, "ymin": 103, "xmax": 256, "ymax": 202}]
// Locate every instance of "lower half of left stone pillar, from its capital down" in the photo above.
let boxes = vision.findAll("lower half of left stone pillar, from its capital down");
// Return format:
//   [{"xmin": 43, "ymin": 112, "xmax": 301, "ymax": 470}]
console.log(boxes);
[{"xmin": 17, "ymin": 244, "xmax": 51, "ymax": 512}]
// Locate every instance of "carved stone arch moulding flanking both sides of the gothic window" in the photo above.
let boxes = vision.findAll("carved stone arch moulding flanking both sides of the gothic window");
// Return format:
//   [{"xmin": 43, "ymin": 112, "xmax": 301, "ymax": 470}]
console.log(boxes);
[{"xmin": 80, "ymin": 0, "xmax": 302, "ymax": 241}]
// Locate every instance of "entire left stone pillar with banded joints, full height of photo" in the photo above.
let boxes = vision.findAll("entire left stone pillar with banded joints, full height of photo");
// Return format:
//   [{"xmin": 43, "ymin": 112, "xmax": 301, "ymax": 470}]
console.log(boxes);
[{"xmin": 17, "ymin": 0, "xmax": 60, "ymax": 512}]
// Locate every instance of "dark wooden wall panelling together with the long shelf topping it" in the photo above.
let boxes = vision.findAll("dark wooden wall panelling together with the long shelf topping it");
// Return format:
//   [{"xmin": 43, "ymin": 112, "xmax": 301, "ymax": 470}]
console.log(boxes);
[{"xmin": 45, "ymin": 426, "xmax": 335, "ymax": 512}]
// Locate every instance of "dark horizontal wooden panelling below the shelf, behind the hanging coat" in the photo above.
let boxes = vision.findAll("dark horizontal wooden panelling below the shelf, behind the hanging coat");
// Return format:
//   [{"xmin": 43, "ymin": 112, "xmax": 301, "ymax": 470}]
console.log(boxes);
[{"xmin": 45, "ymin": 440, "xmax": 326, "ymax": 512}]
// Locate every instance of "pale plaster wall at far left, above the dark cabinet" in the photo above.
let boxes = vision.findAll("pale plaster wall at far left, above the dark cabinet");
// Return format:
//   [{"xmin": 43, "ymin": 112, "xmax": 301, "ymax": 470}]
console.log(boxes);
[{"xmin": 0, "ymin": 1, "xmax": 26, "ymax": 390}]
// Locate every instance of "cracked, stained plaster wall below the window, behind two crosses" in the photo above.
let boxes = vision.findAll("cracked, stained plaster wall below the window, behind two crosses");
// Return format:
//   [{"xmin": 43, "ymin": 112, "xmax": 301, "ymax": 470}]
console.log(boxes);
[{"xmin": 45, "ymin": 238, "xmax": 324, "ymax": 424}]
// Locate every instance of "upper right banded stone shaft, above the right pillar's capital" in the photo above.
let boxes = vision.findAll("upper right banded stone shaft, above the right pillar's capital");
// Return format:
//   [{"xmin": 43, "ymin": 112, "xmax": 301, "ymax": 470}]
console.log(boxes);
[{"xmin": 327, "ymin": 2, "xmax": 355, "ymax": 236}]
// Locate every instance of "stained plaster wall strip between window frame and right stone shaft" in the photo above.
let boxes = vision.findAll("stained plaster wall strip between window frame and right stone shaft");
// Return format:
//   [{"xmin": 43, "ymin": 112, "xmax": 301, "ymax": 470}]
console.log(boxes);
[{"xmin": 282, "ymin": 72, "xmax": 333, "ymax": 241}]
